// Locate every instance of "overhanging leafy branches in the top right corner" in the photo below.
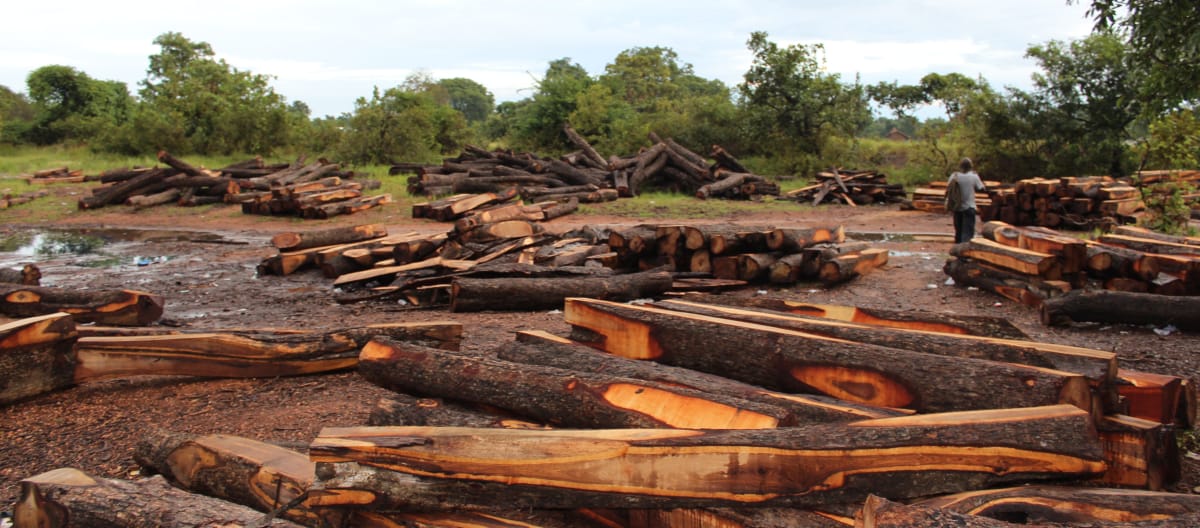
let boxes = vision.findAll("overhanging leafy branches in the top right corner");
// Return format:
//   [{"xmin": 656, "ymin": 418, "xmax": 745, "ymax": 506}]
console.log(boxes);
[{"xmin": 1069, "ymin": 0, "xmax": 1200, "ymax": 114}]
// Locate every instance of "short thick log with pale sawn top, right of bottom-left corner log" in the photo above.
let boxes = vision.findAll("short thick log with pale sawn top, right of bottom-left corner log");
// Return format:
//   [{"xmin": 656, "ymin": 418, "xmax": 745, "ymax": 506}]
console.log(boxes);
[{"xmin": 133, "ymin": 432, "xmax": 328, "ymax": 526}]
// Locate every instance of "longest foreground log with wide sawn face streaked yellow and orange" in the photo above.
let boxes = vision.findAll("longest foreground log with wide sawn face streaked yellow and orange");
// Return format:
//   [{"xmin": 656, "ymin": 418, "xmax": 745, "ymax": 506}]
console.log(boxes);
[{"xmin": 308, "ymin": 406, "xmax": 1104, "ymax": 511}]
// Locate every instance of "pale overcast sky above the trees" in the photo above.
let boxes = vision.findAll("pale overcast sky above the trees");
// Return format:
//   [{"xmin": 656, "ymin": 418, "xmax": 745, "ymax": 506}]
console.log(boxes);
[{"xmin": 0, "ymin": 0, "xmax": 1091, "ymax": 116}]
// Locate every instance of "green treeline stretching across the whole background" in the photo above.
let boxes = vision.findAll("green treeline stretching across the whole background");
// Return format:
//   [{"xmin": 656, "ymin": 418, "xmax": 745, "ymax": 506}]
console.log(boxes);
[{"xmin": 0, "ymin": 0, "xmax": 1200, "ymax": 181}]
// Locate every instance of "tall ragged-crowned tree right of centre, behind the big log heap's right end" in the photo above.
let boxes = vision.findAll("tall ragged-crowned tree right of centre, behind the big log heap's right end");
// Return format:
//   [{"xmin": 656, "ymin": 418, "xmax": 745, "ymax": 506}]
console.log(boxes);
[{"xmin": 738, "ymin": 31, "xmax": 870, "ymax": 166}]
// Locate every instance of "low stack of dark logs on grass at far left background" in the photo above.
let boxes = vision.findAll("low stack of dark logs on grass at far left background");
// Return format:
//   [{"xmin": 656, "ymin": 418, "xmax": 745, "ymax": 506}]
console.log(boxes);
[{"xmin": 79, "ymin": 151, "xmax": 391, "ymax": 218}]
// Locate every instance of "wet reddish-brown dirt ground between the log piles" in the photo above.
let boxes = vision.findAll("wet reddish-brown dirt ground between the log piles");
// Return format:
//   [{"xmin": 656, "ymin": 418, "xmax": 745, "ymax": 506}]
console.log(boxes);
[{"xmin": 0, "ymin": 200, "xmax": 1200, "ymax": 511}]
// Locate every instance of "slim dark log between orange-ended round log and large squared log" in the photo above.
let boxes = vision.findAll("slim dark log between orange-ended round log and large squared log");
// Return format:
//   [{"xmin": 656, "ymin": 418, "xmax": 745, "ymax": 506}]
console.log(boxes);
[{"xmin": 496, "ymin": 330, "xmax": 904, "ymax": 424}]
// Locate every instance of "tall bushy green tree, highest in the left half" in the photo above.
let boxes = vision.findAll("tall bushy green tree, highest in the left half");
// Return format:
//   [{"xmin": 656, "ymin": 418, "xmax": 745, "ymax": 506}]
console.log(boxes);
[{"xmin": 132, "ymin": 32, "xmax": 289, "ymax": 154}]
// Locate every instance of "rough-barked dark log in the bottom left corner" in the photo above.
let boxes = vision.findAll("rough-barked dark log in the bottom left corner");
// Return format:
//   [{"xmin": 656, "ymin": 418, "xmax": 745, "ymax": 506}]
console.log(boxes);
[{"xmin": 13, "ymin": 468, "xmax": 301, "ymax": 528}]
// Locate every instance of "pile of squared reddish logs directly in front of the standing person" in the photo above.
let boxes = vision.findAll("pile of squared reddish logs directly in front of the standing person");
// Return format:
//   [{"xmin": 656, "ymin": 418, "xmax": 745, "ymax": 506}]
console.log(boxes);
[{"xmin": 944, "ymin": 221, "xmax": 1200, "ymax": 312}]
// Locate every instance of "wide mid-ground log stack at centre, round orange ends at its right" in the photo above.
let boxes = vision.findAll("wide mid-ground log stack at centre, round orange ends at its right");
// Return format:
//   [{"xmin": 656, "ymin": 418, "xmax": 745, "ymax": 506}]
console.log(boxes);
[{"xmin": 258, "ymin": 220, "xmax": 888, "ymax": 311}]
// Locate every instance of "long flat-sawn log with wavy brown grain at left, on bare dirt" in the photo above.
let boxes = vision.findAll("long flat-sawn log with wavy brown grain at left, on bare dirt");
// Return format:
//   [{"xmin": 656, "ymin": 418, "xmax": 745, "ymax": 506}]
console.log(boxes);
[{"xmin": 74, "ymin": 322, "xmax": 462, "ymax": 383}]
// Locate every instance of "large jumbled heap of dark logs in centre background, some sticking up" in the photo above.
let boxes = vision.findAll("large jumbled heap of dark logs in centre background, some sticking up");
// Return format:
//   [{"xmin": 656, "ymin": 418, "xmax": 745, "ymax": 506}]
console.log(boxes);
[{"xmin": 390, "ymin": 125, "xmax": 779, "ymax": 203}]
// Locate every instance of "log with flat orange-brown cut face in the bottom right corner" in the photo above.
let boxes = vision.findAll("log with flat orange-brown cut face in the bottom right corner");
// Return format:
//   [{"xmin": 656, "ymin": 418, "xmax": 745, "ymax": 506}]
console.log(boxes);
[{"xmin": 914, "ymin": 485, "xmax": 1200, "ymax": 523}]
